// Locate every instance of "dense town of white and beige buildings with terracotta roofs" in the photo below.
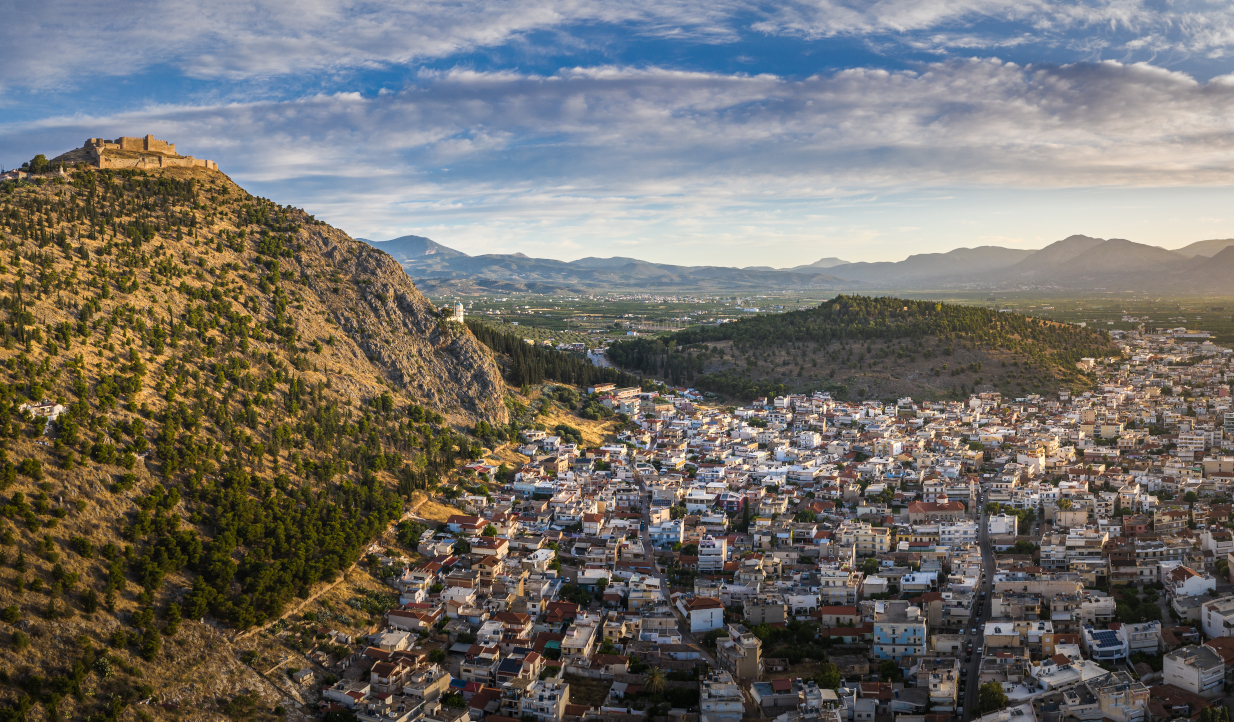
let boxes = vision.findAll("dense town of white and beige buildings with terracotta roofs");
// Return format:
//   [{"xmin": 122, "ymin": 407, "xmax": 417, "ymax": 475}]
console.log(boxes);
[{"xmin": 315, "ymin": 333, "xmax": 1234, "ymax": 722}]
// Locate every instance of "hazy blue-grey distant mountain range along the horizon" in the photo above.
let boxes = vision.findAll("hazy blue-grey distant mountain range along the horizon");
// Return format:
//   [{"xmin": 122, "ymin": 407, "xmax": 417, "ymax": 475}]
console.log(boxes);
[{"xmin": 359, "ymin": 236, "xmax": 1234, "ymax": 294}]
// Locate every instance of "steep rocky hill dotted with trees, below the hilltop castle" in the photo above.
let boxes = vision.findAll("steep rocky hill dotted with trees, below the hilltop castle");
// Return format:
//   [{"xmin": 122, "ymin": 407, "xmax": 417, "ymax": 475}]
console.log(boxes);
[{"xmin": 0, "ymin": 159, "xmax": 508, "ymax": 720}]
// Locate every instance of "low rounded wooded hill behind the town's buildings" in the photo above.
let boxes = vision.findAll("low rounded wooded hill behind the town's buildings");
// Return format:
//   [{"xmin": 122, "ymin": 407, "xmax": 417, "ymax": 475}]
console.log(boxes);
[{"xmin": 608, "ymin": 296, "xmax": 1118, "ymax": 400}]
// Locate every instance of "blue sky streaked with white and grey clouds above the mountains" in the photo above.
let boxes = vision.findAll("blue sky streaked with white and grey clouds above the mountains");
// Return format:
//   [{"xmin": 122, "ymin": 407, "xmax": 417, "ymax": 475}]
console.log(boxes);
[{"xmin": 0, "ymin": 0, "xmax": 1234, "ymax": 265}]
